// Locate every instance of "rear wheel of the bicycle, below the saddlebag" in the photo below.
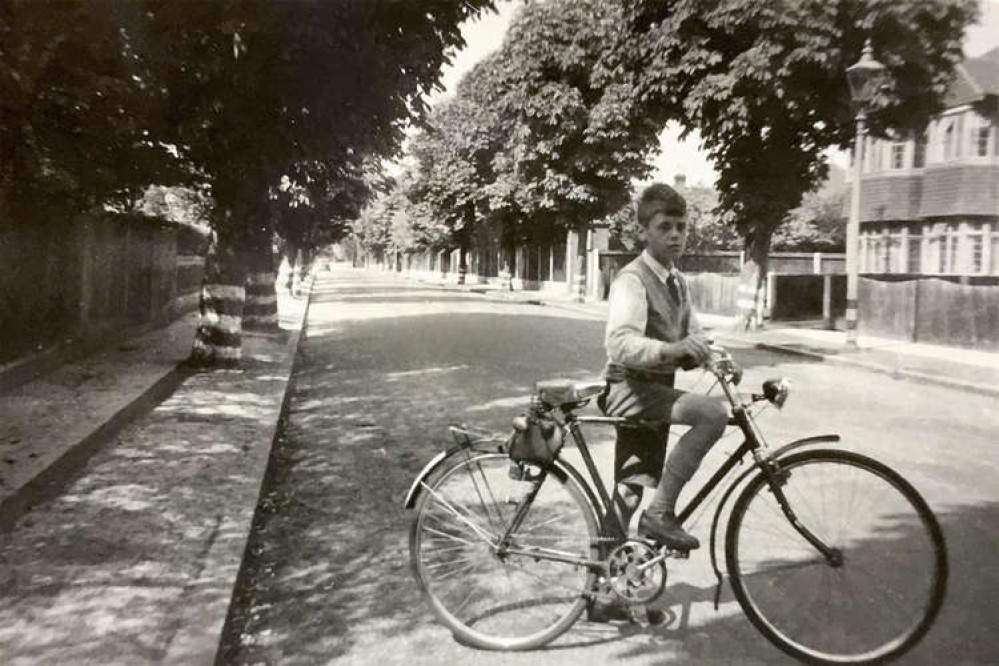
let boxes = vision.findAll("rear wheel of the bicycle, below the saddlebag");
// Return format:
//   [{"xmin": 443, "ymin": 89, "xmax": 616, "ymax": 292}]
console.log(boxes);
[{"xmin": 410, "ymin": 453, "xmax": 598, "ymax": 650}]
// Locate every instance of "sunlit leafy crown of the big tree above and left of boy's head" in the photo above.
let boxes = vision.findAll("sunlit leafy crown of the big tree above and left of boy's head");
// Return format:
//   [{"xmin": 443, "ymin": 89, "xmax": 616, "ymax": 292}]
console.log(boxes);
[{"xmin": 396, "ymin": 0, "xmax": 656, "ymax": 254}]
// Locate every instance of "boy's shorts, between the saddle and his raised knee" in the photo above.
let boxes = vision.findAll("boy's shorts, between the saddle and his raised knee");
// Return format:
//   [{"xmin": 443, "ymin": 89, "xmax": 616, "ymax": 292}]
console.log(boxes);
[{"xmin": 600, "ymin": 379, "xmax": 684, "ymax": 488}]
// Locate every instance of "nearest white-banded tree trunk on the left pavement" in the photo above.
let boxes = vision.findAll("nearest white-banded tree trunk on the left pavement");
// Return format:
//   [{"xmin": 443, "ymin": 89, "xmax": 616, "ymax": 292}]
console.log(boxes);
[{"xmin": 188, "ymin": 232, "xmax": 247, "ymax": 367}]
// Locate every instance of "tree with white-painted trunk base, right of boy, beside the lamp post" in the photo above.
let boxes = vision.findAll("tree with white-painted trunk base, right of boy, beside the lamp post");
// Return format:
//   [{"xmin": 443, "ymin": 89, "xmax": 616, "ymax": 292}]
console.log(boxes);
[{"xmin": 621, "ymin": 0, "xmax": 978, "ymax": 327}]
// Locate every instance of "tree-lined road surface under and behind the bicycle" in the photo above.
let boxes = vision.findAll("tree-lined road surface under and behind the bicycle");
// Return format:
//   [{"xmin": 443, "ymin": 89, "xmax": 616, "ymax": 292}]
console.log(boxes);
[{"xmin": 224, "ymin": 269, "xmax": 999, "ymax": 666}]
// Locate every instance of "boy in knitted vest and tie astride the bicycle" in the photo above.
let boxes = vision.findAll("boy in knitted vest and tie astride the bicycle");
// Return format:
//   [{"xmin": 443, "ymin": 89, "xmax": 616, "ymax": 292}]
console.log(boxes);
[{"xmin": 601, "ymin": 183, "xmax": 728, "ymax": 550}]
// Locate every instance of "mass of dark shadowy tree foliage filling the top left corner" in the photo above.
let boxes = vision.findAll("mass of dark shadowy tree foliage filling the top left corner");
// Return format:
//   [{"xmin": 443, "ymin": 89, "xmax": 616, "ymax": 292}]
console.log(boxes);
[{"xmin": 0, "ymin": 0, "xmax": 492, "ymax": 252}]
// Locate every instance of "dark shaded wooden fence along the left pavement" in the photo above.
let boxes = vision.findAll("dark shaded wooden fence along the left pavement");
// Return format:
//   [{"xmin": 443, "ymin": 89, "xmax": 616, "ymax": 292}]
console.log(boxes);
[{"xmin": 0, "ymin": 215, "xmax": 205, "ymax": 363}]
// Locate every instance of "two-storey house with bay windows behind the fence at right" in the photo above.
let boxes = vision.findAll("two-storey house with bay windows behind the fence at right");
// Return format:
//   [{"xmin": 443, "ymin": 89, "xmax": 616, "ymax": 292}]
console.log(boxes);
[{"xmin": 858, "ymin": 48, "xmax": 999, "ymax": 277}]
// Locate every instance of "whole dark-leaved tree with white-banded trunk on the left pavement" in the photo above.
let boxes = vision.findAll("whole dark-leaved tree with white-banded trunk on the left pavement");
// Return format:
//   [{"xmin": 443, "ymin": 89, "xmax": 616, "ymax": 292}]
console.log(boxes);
[{"xmin": 145, "ymin": 0, "xmax": 492, "ymax": 365}]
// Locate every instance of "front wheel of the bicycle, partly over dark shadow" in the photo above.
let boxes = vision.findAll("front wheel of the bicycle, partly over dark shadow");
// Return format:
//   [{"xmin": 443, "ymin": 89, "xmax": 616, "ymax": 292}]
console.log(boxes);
[{"xmin": 725, "ymin": 450, "xmax": 947, "ymax": 664}]
